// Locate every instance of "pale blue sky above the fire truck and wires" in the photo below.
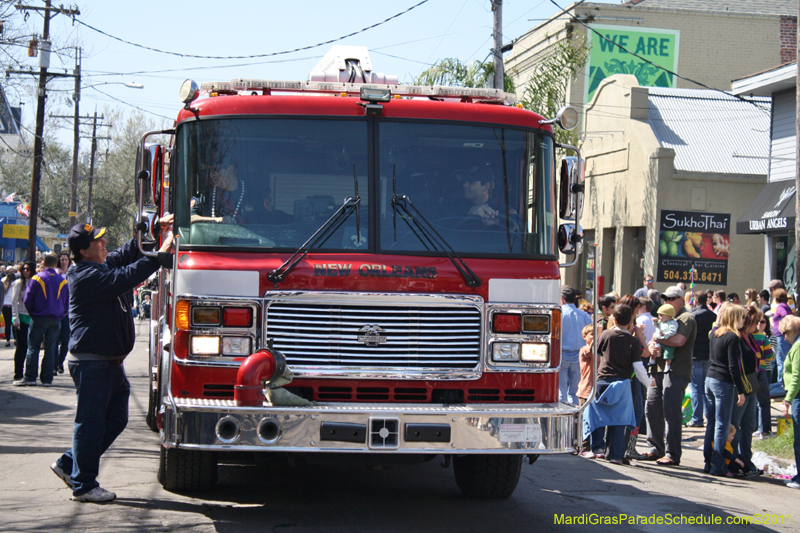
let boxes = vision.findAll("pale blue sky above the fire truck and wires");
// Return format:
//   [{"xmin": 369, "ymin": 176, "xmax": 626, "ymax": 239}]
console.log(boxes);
[{"xmin": 3, "ymin": 0, "xmax": 619, "ymax": 148}]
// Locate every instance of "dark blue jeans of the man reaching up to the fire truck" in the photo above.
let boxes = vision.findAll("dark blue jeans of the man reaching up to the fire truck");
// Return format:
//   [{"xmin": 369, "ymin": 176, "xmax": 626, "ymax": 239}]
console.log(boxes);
[{"xmin": 56, "ymin": 361, "xmax": 131, "ymax": 496}]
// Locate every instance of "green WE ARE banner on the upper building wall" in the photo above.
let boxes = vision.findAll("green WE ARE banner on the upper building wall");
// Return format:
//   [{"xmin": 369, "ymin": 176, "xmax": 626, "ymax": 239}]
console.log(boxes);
[{"xmin": 585, "ymin": 24, "xmax": 680, "ymax": 103}]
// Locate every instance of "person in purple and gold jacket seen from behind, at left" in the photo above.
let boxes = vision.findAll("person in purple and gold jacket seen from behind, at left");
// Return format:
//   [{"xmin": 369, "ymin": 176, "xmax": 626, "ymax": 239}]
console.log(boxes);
[{"xmin": 13, "ymin": 254, "xmax": 69, "ymax": 387}]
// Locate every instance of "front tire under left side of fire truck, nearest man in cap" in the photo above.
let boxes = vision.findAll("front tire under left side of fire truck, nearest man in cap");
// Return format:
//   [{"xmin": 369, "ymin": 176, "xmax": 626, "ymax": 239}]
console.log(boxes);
[{"xmin": 158, "ymin": 446, "xmax": 217, "ymax": 492}]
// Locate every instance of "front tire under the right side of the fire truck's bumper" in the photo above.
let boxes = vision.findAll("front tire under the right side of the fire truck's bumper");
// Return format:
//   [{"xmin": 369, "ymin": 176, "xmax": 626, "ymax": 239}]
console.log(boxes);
[{"xmin": 453, "ymin": 455, "xmax": 523, "ymax": 499}]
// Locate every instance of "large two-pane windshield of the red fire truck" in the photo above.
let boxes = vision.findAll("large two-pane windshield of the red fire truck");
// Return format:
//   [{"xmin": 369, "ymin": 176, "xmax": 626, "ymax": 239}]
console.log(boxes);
[{"xmin": 172, "ymin": 117, "xmax": 556, "ymax": 257}]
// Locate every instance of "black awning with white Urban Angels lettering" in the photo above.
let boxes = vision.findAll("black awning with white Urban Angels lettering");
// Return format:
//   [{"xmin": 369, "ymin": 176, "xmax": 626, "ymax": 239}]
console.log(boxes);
[{"xmin": 736, "ymin": 180, "xmax": 797, "ymax": 234}]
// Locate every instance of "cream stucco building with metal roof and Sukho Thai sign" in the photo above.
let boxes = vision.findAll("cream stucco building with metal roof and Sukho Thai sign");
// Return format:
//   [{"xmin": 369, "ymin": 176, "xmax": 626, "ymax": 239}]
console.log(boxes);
[{"xmin": 565, "ymin": 75, "xmax": 771, "ymax": 300}]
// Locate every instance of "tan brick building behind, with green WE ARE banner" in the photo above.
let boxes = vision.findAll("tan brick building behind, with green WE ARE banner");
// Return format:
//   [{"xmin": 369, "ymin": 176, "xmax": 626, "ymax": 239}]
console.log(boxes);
[{"xmin": 505, "ymin": 0, "xmax": 797, "ymax": 128}]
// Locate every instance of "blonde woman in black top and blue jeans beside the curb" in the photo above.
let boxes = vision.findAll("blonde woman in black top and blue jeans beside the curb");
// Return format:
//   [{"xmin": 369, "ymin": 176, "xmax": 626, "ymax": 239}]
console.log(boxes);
[{"xmin": 703, "ymin": 305, "xmax": 745, "ymax": 477}]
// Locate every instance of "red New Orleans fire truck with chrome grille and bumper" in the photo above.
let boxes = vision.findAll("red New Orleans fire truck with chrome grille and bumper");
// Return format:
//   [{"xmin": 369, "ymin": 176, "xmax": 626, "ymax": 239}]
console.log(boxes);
[{"xmin": 137, "ymin": 49, "xmax": 583, "ymax": 497}]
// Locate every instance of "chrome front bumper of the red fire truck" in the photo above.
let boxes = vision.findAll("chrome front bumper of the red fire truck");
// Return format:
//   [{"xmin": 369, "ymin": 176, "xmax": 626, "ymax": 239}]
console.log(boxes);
[{"xmin": 162, "ymin": 398, "xmax": 580, "ymax": 454}]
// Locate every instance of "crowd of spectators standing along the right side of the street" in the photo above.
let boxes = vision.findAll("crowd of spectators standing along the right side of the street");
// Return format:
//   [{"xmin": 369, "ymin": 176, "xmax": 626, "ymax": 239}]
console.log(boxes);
[{"xmin": 560, "ymin": 276, "xmax": 800, "ymax": 488}]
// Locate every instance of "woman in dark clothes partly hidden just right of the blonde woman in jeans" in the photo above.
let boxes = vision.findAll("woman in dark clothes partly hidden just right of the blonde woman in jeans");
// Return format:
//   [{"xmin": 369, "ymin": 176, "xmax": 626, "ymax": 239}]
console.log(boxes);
[{"xmin": 731, "ymin": 307, "xmax": 764, "ymax": 477}]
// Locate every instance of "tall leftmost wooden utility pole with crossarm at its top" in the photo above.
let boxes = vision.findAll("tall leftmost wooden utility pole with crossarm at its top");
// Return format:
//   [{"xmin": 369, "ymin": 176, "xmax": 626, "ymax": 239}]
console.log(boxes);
[{"xmin": 14, "ymin": 0, "xmax": 81, "ymax": 261}]
